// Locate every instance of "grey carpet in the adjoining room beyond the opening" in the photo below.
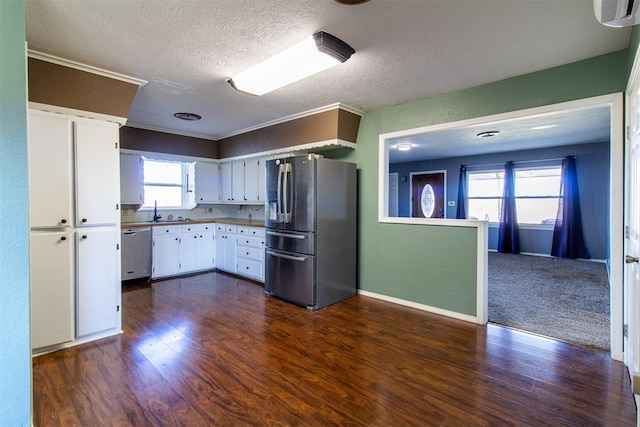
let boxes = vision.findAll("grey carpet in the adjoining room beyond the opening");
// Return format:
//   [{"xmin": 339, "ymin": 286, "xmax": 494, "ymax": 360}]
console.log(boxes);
[{"xmin": 489, "ymin": 252, "xmax": 610, "ymax": 351}]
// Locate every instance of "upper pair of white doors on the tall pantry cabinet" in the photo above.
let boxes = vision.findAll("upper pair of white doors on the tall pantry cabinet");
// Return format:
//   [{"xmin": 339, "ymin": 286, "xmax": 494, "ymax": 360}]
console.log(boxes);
[{"xmin": 29, "ymin": 110, "xmax": 120, "ymax": 228}]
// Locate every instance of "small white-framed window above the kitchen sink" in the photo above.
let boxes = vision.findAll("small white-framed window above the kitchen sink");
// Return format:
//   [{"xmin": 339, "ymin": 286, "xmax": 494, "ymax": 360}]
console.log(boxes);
[{"xmin": 142, "ymin": 157, "xmax": 196, "ymax": 209}]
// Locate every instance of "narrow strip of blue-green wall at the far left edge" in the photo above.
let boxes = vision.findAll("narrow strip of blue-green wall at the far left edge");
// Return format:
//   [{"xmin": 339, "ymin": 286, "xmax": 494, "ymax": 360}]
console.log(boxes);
[{"xmin": 0, "ymin": 0, "xmax": 31, "ymax": 426}]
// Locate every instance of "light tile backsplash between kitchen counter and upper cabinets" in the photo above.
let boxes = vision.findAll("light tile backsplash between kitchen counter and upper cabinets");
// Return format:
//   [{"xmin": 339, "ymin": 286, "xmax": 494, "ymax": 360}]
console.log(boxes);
[{"xmin": 121, "ymin": 205, "xmax": 264, "ymax": 224}]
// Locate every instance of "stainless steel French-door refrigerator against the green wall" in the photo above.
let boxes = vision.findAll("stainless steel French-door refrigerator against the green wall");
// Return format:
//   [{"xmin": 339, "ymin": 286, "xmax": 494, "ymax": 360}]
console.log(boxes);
[{"xmin": 265, "ymin": 154, "xmax": 357, "ymax": 310}]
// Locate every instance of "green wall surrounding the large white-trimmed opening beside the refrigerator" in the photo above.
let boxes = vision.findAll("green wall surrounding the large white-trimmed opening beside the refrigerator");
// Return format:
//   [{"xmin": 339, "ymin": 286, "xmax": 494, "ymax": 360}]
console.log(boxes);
[{"xmin": 332, "ymin": 49, "xmax": 629, "ymax": 316}]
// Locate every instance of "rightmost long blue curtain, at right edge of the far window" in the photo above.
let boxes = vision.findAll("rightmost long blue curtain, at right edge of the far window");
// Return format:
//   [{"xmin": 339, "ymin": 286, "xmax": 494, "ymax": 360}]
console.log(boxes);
[{"xmin": 551, "ymin": 156, "xmax": 590, "ymax": 259}]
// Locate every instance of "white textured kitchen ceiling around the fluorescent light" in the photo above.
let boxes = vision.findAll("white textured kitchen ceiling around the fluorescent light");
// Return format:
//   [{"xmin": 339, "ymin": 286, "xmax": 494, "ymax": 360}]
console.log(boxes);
[{"xmin": 25, "ymin": 0, "xmax": 631, "ymax": 139}]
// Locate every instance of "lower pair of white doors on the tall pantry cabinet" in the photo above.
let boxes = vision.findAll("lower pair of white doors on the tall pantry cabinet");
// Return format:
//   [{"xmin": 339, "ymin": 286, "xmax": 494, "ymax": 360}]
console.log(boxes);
[{"xmin": 29, "ymin": 227, "xmax": 120, "ymax": 350}]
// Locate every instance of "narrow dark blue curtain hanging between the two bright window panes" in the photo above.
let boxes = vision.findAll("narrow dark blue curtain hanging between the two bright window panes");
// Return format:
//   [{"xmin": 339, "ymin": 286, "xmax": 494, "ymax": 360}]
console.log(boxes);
[{"xmin": 498, "ymin": 162, "xmax": 520, "ymax": 254}]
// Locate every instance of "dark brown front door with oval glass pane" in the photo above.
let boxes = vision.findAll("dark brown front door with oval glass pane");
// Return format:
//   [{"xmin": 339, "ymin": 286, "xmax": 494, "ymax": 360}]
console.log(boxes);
[{"xmin": 411, "ymin": 172, "xmax": 444, "ymax": 218}]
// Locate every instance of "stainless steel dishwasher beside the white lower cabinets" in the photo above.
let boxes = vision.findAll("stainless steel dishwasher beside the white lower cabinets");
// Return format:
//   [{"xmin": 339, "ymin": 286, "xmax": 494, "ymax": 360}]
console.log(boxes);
[{"xmin": 121, "ymin": 227, "xmax": 151, "ymax": 281}]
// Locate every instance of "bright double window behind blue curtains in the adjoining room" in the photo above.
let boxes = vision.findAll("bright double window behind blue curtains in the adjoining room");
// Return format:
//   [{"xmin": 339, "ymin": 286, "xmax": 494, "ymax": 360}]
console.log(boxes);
[{"xmin": 467, "ymin": 165, "xmax": 561, "ymax": 225}]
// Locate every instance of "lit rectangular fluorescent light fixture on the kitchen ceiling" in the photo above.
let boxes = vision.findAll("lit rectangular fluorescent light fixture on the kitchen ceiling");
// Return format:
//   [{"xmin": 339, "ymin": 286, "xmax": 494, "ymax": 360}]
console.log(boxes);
[{"xmin": 227, "ymin": 31, "xmax": 355, "ymax": 96}]
